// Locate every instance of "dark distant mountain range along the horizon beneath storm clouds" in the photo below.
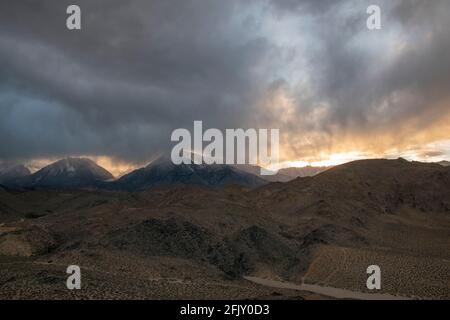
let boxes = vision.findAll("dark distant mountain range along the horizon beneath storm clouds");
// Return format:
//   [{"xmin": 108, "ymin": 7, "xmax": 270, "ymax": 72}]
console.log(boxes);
[{"xmin": 0, "ymin": 156, "xmax": 449, "ymax": 191}]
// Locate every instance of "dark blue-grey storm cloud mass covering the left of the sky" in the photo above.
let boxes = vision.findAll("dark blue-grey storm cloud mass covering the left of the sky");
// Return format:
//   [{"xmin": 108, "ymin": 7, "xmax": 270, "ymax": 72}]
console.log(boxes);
[{"xmin": 0, "ymin": 1, "xmax": 269, "ymax": 164}]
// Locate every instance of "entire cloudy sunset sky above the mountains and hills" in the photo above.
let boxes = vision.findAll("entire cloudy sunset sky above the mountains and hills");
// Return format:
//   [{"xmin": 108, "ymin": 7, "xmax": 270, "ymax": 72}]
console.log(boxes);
[{"xmin": 0, "ymin": 0, "xmax": 450, "ymax": 175}]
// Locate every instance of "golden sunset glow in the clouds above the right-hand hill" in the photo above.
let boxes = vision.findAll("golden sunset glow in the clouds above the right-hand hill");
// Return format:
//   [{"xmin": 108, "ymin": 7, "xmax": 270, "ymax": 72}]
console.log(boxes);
[{"xmin": 256, "ymin": 81, "xmax": 450, "ymax": 168}]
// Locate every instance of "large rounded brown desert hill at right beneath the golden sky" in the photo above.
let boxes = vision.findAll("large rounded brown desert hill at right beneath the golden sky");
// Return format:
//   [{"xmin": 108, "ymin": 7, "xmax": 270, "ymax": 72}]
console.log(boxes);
[{"xmin": 252, "ymin": 159, "xmax": 450, "ymax": 280}]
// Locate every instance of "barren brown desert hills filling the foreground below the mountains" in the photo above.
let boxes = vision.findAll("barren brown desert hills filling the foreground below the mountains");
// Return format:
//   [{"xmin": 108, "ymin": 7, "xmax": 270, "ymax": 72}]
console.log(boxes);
[{"xmin": 0, "ymin": 159, "xmax": 450, "ymax": 299}]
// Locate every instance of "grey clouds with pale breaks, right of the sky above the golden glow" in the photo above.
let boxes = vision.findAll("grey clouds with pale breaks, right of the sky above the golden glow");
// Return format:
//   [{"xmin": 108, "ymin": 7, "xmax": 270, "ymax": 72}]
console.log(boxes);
[{"xmin": 262, "ymin": 0, "xmax": 450, "ymax": 159}]
